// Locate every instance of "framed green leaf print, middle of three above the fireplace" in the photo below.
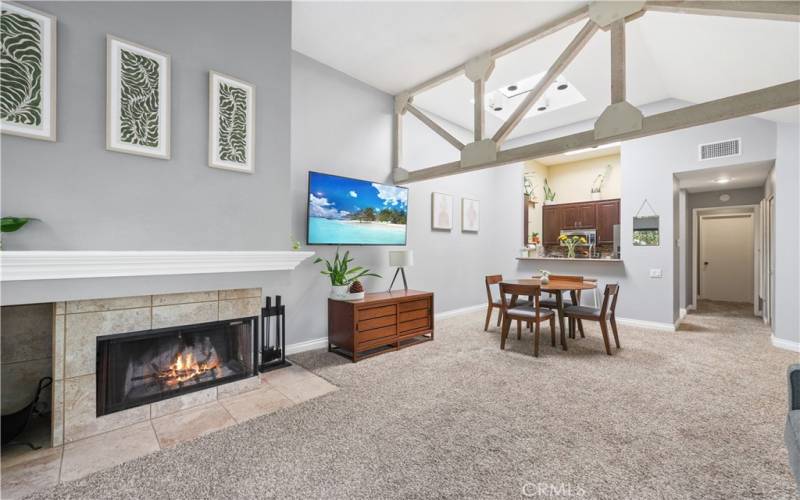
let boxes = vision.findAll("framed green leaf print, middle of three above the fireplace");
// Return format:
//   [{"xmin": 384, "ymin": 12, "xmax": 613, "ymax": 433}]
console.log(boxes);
[{"xmin": 106, "ymin": 35, "xmax": 170, "ymax": 159}]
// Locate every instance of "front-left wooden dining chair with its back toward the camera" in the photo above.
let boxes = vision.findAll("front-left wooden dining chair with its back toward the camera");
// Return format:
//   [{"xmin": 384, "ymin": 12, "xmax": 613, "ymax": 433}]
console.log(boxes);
[{"xmin": 500, "ymin": 283, "xmax": 556, "ymax": 357}]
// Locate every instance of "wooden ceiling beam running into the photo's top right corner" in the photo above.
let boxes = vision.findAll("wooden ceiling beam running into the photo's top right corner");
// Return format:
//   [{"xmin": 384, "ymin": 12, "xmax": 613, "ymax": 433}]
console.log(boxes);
[{"xmin": 645, "ymin": 0, "xmax": 800, "ymax": 22}]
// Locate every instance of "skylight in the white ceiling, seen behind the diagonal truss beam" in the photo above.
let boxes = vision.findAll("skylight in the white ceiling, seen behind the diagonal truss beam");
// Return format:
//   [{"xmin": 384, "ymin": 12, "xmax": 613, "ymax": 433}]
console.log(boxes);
[{"xmin": 471, "ymin": 72, "xmax": 586, "ymax": 121}]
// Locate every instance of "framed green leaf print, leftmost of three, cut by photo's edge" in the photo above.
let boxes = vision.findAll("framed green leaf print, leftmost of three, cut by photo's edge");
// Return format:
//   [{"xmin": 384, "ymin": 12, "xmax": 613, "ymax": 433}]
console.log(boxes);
[{"xmin": 0, "ymin": 2, "xmax": 57, "ymax": 141}]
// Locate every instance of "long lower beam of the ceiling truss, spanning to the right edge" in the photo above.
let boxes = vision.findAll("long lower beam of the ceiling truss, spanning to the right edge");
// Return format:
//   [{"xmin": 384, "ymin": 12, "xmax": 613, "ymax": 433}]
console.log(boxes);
[{"xmin": 398, "ymin": 80, "xmax": 800, "ymax": 184}]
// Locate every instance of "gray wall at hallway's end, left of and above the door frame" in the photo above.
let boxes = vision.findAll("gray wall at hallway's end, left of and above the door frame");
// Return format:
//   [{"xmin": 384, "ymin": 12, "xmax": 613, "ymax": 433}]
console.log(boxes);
[{"xmin": 681, "ymin": 186, "xmax": 764, "ymax": 307}]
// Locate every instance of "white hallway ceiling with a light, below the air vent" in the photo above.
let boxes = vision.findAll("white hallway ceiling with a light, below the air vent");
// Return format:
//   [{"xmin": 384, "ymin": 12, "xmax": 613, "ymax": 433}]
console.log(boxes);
[{"xmin": 675, "ymin": 161, "xmax": 775, "ymax": 193}]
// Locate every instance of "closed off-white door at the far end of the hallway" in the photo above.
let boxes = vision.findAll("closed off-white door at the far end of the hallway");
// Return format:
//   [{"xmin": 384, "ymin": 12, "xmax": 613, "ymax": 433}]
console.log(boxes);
[{"xmin": 699, "ymin": 214, "xmax": 754, "ymax": 303}]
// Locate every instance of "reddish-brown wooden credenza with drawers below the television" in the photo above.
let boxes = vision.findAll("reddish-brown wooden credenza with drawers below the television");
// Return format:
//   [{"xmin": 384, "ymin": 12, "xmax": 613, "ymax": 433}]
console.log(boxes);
[{"xmin": 328, "ymin": 290, "xmax": 433, "ymax": 363}]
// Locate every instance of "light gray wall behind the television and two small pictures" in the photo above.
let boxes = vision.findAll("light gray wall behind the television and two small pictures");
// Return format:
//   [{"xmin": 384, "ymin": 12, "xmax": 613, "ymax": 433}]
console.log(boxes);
[{"xmin": 288, "ymin": 53, "xmax": 522, "ymax": 343}]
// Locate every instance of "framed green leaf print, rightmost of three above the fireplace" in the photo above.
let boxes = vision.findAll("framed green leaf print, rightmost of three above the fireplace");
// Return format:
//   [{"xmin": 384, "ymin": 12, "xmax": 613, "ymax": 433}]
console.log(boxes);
[{"xmin": 208, "ymin": 71, "xmax": 256, "ymax": 174}]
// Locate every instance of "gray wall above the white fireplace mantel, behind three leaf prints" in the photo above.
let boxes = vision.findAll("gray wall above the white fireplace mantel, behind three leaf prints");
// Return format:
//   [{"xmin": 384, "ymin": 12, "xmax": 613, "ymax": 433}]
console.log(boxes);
[{"xmin": 2, "ymin": 2, "xmax": 291, "ymax": 250}]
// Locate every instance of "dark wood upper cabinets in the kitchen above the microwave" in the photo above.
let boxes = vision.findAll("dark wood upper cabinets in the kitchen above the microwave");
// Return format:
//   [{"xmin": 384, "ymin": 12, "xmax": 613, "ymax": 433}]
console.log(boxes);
[{"xmin": 542, "ymin": 200, "xmax": 620, "ymax": 245}]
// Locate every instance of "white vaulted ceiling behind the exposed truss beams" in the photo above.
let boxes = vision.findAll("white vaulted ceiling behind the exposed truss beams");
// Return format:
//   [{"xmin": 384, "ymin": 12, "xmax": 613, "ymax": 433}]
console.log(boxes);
[{"xmin": 292, "ymin": 2, "xmax": 800, "ymax": 141}]
